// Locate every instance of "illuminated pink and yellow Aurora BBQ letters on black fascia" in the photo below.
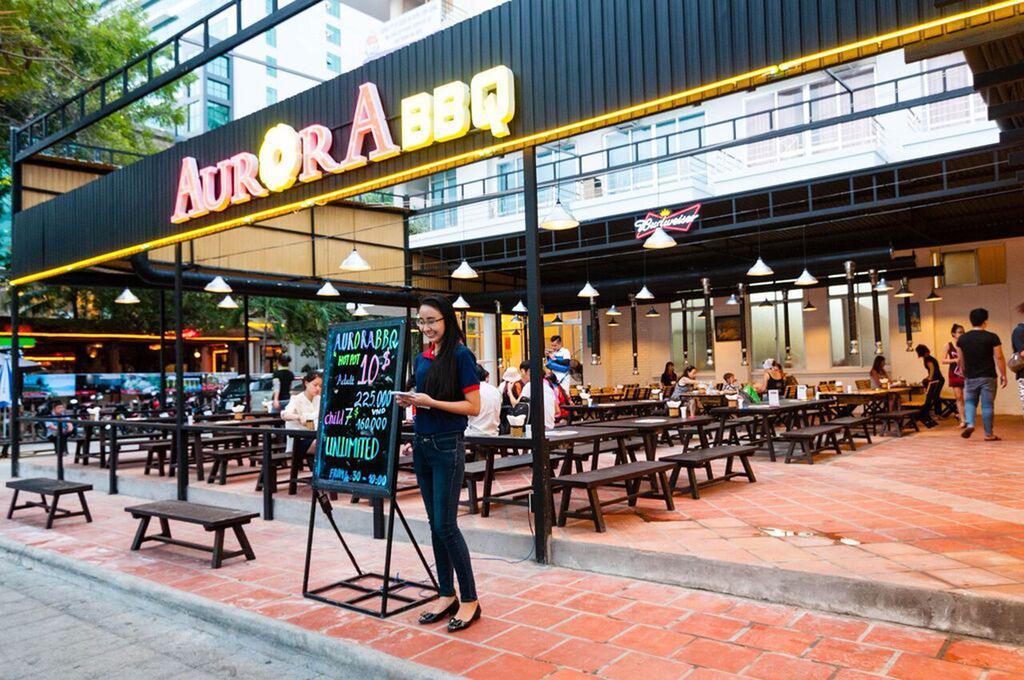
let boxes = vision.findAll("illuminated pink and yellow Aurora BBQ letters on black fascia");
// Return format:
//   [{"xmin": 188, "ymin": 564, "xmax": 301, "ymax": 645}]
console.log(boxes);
[{"xmin": 171, "ymin": 66, "xmax": 515, "ymax": 224}]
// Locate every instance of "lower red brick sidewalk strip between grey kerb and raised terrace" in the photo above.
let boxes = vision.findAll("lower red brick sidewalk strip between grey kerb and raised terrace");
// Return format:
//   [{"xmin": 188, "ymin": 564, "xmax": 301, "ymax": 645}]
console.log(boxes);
[{"xmin": 0, "ymin": 481, "xmax": 1024, "ymax": 680}]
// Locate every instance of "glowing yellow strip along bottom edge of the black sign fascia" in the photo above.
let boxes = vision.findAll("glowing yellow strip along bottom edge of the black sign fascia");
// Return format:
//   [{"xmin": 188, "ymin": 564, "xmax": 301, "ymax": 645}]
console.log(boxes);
[{"xmin": 10, "ymin": 0, "xmax": 1024, "ymax": 286}]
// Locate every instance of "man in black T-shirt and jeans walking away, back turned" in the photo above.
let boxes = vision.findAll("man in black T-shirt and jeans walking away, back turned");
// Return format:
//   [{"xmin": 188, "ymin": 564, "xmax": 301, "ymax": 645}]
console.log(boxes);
[{"xmin": 956, "ymin": 307, "xmax": 1007, "ymax": 441}]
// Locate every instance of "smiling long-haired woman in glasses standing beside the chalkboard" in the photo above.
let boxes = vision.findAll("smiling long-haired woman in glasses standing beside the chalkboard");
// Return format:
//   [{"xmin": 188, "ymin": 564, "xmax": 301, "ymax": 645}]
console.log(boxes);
[{"xmin": 398, "ymin": 297, "xmax": 480, "ymax": 633}]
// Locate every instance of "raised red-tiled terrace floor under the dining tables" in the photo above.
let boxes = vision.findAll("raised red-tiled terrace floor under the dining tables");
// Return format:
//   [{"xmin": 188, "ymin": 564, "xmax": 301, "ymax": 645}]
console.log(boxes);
[{"xmin": 24, "ymin": 418, "xmax": 1024, "ymax": 598}]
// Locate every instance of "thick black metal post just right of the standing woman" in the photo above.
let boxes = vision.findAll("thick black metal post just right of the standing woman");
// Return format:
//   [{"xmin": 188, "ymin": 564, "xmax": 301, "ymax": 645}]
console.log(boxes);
[{"xmin": 522, "ymin": 146, "xmax": 551, "ymax": 562}]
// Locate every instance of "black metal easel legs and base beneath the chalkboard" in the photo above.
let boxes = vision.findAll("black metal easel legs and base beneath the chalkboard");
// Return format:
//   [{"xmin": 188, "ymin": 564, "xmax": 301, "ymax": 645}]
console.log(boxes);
[{"xmin": 302, "ymin": 488, "xmax": 438, "ymax": 619}]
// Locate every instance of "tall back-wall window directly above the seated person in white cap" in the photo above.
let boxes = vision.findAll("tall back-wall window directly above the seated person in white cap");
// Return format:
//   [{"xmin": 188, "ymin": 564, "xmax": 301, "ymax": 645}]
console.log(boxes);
[{"xmin": 750, "ymin": 291, "xmax": 806, "ymax": 369}]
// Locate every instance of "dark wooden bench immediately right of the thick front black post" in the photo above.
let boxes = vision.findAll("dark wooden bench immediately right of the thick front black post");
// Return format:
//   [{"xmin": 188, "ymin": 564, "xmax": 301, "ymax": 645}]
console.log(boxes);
[{"xmin": 551, "ymin": 461, "xmax": 676, "ymax": 533}]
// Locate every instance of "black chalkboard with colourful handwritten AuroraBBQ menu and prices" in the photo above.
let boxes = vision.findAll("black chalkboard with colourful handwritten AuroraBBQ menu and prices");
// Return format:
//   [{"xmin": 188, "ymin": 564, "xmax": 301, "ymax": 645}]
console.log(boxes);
[{"xmin": 313, "ymin": 318, "xmax": 406, "ymax": 498}]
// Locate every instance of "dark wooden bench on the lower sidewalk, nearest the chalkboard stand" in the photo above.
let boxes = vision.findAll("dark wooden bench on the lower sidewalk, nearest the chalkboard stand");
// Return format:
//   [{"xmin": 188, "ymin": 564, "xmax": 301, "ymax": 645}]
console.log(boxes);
[{"xmin": 125, "ymin": 501, "xmax": 259, "ymax": 569}]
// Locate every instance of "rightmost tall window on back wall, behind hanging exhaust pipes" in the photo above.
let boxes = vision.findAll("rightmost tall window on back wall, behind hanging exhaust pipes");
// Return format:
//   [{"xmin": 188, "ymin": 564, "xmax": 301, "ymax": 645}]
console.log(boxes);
[{"xmin": 828, "ymin": 284, "xmax": 889, "ymax": 367}]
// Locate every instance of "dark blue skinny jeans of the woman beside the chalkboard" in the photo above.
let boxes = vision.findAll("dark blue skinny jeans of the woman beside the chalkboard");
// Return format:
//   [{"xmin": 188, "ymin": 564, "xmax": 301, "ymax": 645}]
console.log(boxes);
[{"xmin": 413, "ymin": 432, "xmax": 476, "ymax": 602}]
